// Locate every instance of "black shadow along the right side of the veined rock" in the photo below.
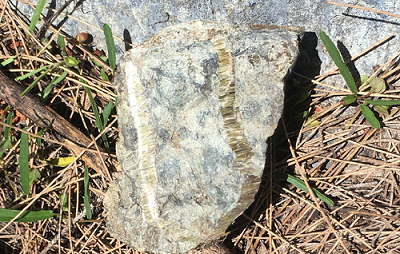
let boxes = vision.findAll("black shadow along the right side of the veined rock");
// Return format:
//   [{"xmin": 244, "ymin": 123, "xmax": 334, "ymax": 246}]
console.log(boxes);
[{"xmin": 224, "ymin": 32, "xmax": 321, "ymax": 253}]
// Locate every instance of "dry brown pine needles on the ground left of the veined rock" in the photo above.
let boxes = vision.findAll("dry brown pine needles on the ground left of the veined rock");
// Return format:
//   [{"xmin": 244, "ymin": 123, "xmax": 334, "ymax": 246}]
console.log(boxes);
[{"xmin": 0, "ymin": 1, "xmax": 122, "ymax": 253}]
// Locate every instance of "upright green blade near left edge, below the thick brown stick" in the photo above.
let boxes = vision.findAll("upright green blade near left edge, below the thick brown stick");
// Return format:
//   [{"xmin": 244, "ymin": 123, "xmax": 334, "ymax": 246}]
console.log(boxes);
[{"xmin": 19, "ymin": 132, "xmax": 29, "ymax": 195}]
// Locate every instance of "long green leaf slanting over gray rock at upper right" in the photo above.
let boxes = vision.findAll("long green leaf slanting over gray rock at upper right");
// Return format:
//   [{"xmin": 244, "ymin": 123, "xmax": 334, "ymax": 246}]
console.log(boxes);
[{"xmin": 319, "ymin": 30, "xmax": 358, "ymax": 94}]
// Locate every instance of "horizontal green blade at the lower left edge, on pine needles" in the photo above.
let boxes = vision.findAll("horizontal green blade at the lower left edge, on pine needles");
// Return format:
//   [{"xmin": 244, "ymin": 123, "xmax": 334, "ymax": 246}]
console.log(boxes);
[{"xmin": 0, "ymin": 209, "xmax": 53, "ymax": 222}]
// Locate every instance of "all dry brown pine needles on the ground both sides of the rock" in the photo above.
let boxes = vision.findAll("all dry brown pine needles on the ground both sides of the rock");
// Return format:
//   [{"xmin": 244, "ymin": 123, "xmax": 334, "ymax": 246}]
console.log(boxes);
[{"xmin": 0, "ymin": 0, "xmax": 400, "ymax": 253}]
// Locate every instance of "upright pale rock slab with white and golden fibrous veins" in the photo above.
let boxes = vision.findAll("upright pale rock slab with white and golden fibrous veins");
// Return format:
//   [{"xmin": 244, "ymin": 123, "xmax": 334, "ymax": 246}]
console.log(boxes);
[{"xmin": 104, "ymin": 21, "xmax": 300, "ymax": 253}]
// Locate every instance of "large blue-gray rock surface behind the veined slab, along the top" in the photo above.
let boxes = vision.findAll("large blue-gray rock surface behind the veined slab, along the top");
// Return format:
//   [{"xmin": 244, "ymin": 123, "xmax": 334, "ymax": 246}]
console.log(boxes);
[{"xmin": 12, "ymin": 0, "xmax": 400, "ymax": 77}]
